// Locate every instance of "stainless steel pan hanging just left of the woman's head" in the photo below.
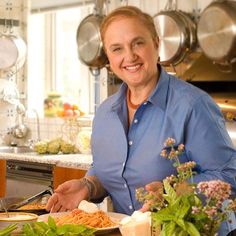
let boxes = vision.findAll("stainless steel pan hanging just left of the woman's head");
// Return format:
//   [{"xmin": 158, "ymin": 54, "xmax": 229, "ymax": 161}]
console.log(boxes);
[{"xmin": 76, "ymin": 14, "xmax": 107, "ymax": 69}]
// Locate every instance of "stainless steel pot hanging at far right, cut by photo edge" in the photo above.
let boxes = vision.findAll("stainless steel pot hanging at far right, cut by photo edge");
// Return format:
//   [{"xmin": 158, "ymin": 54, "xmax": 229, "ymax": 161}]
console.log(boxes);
[{"xmin": 197, "ymin": 1, "xmax": 236, "ymax": 64}]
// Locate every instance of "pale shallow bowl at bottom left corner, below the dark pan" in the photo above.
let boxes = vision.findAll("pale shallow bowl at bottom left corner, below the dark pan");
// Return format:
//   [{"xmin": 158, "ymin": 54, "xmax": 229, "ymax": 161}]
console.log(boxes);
[{"xmin": 0, "ymin": 212, "xmax": 38, "ymax": 229}]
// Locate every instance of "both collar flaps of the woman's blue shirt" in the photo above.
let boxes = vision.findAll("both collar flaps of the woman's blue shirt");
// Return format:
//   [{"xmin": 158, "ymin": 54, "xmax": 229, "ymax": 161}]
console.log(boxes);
[{"xmin": 112, "ymin": 66, "xmax": 169, "ymax": 110}]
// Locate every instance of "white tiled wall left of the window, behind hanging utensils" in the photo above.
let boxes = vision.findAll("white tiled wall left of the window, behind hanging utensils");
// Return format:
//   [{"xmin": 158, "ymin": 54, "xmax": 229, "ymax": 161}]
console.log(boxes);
[{"xmin": 0, "ymin": 0, "xmax": 29, "ymax": 144}]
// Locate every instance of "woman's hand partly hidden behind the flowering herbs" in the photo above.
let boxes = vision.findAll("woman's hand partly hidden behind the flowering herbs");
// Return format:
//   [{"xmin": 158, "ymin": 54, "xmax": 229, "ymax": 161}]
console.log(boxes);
[{"xmin": 140, "ymin": 181, "xmax": 163, "ymax": 212}]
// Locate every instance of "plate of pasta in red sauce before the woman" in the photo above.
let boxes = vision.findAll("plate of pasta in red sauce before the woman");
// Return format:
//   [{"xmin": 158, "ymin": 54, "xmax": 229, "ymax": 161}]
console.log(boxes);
[{"xmin": 38, "ymin": 209, "xmax": 127, "ymax": 234}]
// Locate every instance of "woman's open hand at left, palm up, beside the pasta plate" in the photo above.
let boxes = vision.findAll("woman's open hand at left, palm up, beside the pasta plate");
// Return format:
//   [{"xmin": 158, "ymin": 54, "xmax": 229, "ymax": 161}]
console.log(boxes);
[{"xmin": 46, "ymin": 179, "xmax": 89, "ymax": 212}]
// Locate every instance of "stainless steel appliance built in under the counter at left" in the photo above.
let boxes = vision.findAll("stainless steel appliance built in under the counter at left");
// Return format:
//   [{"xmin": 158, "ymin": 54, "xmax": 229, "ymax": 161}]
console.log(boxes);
[{"xmin": 6, "ymin": 160, "xmax": 53, "ymax": 197}]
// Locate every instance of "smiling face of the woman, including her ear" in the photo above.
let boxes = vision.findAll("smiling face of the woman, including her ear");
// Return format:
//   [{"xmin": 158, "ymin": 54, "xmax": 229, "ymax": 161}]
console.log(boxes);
[{"xmin": 104, "ymin": 17, "xmax": 158, "ymax": 87}]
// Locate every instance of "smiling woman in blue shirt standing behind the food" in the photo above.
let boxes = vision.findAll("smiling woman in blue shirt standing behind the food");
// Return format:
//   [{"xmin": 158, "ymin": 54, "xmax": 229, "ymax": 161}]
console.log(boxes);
[{"xmin": 47, "ymin": 6, "xmax": 236, "ymax": 235}]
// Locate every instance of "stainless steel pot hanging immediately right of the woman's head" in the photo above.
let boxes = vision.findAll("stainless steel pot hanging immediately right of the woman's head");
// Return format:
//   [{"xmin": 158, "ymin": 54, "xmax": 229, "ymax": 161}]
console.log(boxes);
[{"xmin": 154, "ymin": 10, "xmax": 197, "ymax": 66}]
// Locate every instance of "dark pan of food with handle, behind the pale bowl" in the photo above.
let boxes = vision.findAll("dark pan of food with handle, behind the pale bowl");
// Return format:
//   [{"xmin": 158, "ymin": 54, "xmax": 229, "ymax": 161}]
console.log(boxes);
[{"xmin": 0, "ymin": 189, "xmax": 52, "ymax": 215}]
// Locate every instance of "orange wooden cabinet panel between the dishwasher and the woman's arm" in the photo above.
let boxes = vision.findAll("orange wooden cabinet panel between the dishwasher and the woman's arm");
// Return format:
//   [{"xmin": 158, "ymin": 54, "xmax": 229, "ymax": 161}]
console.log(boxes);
[{"xmin": 53, "ymin": 167, "xmax": 86, "ymax": 189}]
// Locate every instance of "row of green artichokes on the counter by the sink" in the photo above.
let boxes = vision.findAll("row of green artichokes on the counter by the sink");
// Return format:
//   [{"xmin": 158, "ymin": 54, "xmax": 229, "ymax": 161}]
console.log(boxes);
[{"xmin": 34, "ymin": 138, "xmax": 77, "ymax": 154}]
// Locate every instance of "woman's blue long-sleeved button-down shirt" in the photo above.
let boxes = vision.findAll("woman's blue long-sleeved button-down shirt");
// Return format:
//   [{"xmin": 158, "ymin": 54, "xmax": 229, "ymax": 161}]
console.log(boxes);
[{"xmin": 87, "ymin": 69, "xmax": 236, "ymax": 235}]
